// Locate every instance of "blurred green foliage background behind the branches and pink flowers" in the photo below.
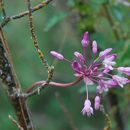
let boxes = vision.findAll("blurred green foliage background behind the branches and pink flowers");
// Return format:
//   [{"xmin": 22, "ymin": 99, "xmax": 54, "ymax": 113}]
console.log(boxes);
[{"xmin": 0, "ymin": 0, "xmax": 130, "ymax": 130}]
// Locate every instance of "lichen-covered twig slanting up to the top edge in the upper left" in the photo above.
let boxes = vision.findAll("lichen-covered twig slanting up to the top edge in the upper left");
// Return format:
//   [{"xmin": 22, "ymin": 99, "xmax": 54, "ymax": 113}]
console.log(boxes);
[{"xmin": 1, "ymin": 0, "xmax": 52, "ymax": 27}]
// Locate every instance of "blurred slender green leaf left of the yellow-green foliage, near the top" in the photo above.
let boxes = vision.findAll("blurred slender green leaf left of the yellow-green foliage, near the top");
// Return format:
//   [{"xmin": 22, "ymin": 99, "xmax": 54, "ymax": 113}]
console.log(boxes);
[{"xmin": 44, "ymin": 12, "xmax": 68, "ymax": 31}]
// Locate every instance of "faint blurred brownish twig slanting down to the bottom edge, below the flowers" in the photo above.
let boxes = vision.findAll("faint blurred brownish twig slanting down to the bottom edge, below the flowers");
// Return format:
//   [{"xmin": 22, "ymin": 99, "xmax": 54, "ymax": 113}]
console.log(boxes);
[{"xmin": 55, "ymin": 92, "xmax": 78, "ymax": 130}]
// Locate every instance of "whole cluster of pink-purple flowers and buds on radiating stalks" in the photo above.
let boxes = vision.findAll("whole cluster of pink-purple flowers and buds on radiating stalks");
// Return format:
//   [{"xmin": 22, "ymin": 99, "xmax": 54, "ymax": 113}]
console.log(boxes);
[{"xmin": 50, "ymin": 32, "xmax": 130, "ymax": 116}]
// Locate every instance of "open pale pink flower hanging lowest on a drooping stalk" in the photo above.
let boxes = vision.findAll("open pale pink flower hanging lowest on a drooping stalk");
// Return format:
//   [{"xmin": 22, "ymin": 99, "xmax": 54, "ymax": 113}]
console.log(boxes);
[{"xmin": 82, "ymin": 99, "xmax": 93, "ymax": 117}]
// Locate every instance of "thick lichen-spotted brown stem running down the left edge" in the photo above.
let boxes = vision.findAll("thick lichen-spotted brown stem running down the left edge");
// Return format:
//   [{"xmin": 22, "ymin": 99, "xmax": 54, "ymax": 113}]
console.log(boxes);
[{"xmin": 0, "ymin": 27, "xmax": 35, "ymax": 130}]
